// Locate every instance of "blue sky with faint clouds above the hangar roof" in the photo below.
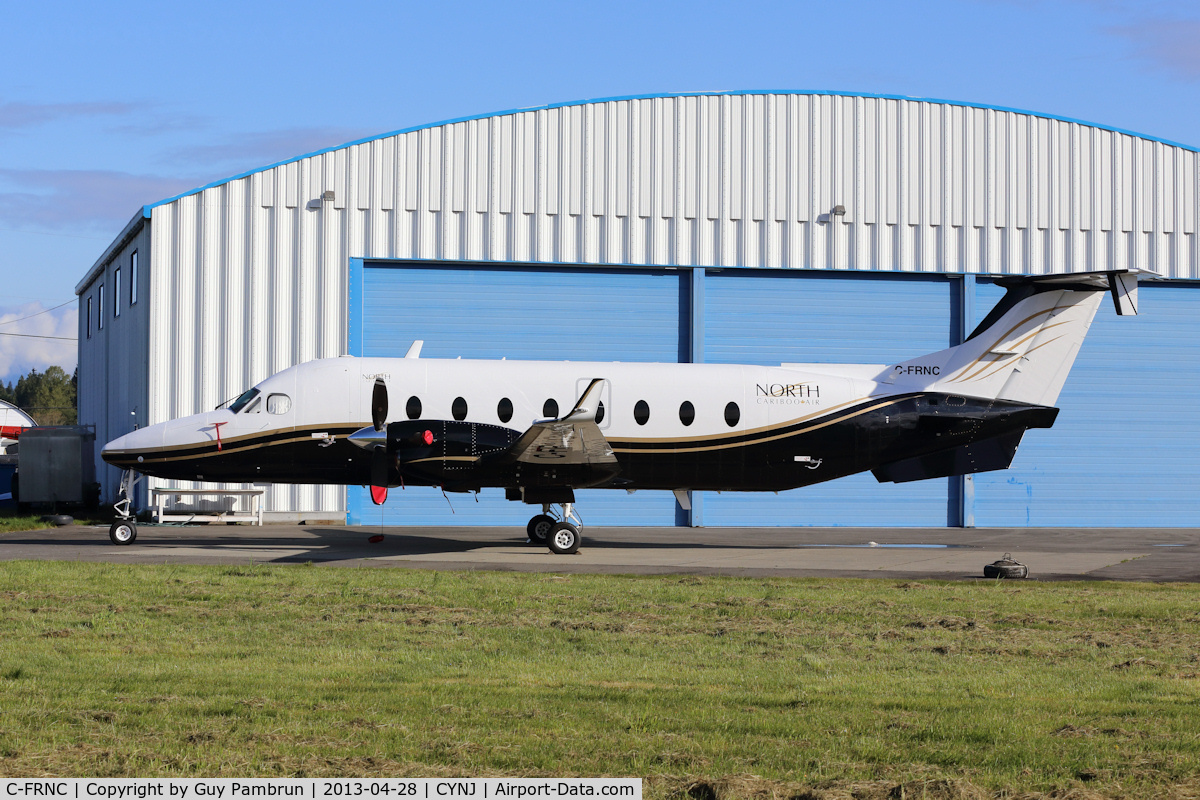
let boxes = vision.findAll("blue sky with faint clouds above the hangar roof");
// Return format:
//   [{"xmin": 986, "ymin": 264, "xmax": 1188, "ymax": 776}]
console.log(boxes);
[{"xmin": 0, "ymin": 0, "xmax": 1200, "ymax": 380}]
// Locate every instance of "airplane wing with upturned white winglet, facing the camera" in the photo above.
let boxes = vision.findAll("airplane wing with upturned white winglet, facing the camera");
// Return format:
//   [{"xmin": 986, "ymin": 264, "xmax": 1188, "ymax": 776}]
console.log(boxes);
[{"xmin": 508, "ymin": 378, "xmax": 617, "ymax": 467}]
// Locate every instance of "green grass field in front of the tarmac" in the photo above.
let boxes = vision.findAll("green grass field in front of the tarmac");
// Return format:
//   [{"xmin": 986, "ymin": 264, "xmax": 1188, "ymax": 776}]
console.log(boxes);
[{"xmin": 0, "ymin": 563, "xmax": 1200, "ymax": 800}]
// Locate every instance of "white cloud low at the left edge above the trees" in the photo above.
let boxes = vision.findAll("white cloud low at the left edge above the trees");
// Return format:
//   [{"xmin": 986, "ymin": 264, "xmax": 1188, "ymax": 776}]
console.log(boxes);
[{"xmin": 0, "ymin": 302, "xmax": 79, "ymax": 383}]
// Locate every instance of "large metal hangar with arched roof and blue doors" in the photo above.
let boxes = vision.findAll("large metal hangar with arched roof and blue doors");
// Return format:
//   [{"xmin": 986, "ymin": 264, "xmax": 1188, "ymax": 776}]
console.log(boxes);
[{"xmin": 76, "ymin": 91, "xmax": 1200, "ymax": 527}]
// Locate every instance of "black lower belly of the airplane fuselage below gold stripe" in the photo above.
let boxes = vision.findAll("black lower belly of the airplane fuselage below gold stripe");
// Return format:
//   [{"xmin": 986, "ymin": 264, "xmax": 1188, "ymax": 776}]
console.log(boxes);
[{"xmin": 106, "ymin": 392, "xmax": 1057, "ymax": 492}]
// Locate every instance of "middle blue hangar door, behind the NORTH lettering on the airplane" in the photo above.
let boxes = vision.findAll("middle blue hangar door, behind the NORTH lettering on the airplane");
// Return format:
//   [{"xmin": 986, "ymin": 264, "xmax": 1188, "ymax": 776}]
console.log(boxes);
[{"xmin": 701, "ymin": 270, "xmax": 962, "ymax": 527}]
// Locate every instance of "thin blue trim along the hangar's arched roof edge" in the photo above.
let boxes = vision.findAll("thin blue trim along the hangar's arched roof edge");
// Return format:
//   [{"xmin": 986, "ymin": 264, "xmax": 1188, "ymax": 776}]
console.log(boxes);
[{"xmin": 142, "ymin": 89, "xmax": 1200, "ymax": 219}]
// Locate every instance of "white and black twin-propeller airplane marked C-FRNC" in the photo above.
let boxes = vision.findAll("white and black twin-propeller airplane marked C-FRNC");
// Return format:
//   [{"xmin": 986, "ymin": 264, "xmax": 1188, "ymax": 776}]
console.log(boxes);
[{"xmin": 102, "ymin": 271, "xmax": 1138, "ymax": 553}]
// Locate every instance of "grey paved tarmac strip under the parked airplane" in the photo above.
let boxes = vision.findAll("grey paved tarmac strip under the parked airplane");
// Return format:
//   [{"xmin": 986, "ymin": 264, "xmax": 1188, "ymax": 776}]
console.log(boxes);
[{"xmin": 0, "ymin": 524, "xmax": 1200, "ymax": 582}]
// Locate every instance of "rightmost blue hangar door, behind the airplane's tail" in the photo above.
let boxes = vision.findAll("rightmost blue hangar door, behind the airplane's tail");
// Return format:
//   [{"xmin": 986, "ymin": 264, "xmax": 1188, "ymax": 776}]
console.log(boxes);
[{"xmin": 974, "ymin": 281, "xmax": 1200, "ymax": 527}]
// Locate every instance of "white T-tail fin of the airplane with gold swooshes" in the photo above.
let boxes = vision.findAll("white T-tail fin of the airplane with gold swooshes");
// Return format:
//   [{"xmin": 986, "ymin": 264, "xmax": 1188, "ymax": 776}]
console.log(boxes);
[{"xmin": 888, "ymin": 271, "xmax": 1138, "ymax": 405}]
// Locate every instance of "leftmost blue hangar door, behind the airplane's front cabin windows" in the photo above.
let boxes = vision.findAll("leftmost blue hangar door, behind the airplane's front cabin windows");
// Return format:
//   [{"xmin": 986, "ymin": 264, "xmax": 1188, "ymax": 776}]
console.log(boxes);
[{"xmin": 347, "ymin": 259, "xmax": 690, "ymax": 525}]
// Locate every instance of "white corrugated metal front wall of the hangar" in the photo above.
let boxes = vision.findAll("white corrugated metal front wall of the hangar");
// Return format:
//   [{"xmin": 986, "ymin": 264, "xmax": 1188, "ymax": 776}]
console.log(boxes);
[{"xmin": 112, "ymin": 94, "xmax": 1200, "ymax": 511}]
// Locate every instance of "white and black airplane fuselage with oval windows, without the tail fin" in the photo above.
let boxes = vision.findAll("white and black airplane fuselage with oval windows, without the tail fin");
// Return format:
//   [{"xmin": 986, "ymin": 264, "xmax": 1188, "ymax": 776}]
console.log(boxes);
[{"xmin": 104, "ymin": 357, "xmax": 1055, "ymax": 500}]
